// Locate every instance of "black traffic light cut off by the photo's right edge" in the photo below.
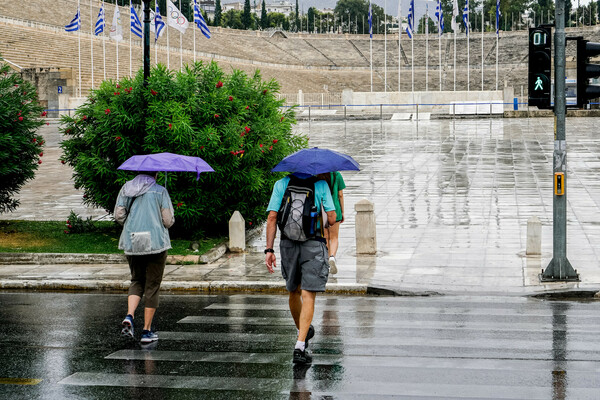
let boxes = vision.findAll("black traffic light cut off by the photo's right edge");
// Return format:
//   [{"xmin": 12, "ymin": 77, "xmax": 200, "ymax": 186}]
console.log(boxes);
[{"xmin": 577, "ymin": 37, "xmax": 600, "ymax": 108}]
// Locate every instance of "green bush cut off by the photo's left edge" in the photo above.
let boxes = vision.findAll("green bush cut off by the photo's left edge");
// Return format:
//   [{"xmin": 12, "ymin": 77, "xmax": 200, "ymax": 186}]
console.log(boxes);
[{"xmin": 0, "ymin": 63, "xmax": 46, "ymax": 214}]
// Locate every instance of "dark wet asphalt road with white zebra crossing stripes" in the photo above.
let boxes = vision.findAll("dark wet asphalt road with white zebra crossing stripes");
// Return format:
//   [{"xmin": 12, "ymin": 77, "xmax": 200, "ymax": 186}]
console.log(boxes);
[{"xmin": 0, "ymin": 292, "xmax": 600, "ymax": 400}]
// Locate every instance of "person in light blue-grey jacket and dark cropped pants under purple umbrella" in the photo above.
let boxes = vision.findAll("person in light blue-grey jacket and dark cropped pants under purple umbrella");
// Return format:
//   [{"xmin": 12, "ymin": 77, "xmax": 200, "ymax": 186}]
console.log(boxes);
[{"xmin": 114, "ymin": 171, "xmax": 175, "ymax": 344}]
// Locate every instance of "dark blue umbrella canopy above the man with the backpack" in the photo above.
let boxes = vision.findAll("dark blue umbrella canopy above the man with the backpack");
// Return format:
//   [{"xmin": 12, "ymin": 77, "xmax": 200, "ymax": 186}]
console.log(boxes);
[{"xmin": 271, "ymin": 147, "xmax": 360, "ymax": 175}]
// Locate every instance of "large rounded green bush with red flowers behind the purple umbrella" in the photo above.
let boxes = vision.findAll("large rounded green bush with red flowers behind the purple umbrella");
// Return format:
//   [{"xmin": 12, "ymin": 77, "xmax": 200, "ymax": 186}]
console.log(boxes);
[{"xmin": 61, "ymin": 63, "xmax": 307, "ymax": 235}]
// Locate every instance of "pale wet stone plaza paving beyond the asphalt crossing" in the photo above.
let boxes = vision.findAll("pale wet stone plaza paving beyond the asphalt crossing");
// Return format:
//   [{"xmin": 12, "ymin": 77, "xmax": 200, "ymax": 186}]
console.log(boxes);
[{"xmin": 0, "ymin": 118, "xmax": 600, "ymax": 294}]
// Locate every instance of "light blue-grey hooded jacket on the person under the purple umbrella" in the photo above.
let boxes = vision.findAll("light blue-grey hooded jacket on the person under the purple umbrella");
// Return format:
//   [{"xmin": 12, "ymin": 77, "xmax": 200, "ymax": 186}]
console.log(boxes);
[{"xmin": 114, "ymin": 174, "xmax": 175, "ymax": 255}]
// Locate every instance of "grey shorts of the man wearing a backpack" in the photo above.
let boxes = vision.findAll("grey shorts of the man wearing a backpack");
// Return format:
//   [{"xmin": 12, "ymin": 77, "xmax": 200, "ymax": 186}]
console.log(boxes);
[{"xmin": 279, "ymin": 239, "xmax": 329, "ymax": 292}]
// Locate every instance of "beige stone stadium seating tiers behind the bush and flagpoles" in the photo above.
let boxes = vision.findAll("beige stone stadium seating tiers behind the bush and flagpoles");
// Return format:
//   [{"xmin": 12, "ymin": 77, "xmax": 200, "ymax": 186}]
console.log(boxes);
[{"xmin": 0, "ymin": 0, "xmax": 600, "ymax": 95}]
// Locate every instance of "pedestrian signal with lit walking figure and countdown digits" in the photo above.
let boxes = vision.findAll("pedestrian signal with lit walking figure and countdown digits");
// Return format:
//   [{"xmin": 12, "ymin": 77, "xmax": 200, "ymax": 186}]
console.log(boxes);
[{"xmin": 528, "ymin": 26, "xmax": 552, "ymax": 109}]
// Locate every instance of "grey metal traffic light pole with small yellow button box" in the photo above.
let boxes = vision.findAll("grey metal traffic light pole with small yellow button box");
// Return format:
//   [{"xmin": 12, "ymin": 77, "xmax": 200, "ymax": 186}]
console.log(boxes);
[{"xmin": 540, "ymin": 0, "xmax": 579, "ymax": 282}]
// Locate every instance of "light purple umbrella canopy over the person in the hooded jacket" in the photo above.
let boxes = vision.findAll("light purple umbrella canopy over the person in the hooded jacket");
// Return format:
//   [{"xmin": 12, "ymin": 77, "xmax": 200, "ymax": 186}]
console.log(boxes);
[{"xmin": 118, "ymin": 153, "xmax": 215, "ymax": 180}]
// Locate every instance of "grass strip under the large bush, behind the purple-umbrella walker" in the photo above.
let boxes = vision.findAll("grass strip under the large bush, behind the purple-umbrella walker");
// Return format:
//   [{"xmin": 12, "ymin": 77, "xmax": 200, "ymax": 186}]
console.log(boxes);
[{"xmin": 0, "ymin": 221, "xmax": 226, "ymax": 255}]
